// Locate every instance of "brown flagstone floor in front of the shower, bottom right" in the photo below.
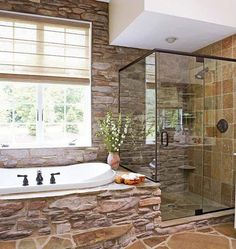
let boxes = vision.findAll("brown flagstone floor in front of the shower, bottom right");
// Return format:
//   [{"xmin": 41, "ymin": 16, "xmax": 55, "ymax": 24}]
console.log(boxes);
[{"xmin": 126, "ymin": 223, "xmax": 236, "ymax": 249}]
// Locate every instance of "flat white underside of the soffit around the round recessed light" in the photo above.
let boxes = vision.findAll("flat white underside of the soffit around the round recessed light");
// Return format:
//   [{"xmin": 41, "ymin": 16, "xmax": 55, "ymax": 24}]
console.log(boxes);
[{"xmin": 111, "ymin": 12, "xmax": 236, "ymax": 52}]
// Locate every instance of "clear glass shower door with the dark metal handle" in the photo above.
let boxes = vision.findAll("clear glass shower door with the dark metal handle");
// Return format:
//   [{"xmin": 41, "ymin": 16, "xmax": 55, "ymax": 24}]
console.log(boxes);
[{"xmin": 156, "ymin": 53, "xmax": 205, "ymax": 220}]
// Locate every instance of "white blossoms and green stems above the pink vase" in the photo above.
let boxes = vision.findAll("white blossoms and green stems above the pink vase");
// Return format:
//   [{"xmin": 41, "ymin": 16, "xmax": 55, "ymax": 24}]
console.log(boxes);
[{"xmin": 97, "ymin": 111, "xmax": 131, "ymax": 152}]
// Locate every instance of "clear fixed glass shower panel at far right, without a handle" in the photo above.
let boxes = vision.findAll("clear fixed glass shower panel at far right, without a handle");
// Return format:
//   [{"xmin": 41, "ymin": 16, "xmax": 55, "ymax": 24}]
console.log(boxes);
[{"xmin": 202, "ymin": 58, "xmax": 236, "ymax": 213}]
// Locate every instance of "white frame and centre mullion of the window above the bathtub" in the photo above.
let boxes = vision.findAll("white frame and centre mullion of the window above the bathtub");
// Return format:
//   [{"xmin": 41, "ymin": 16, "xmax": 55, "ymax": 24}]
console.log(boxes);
[{"xmin": 0, "ymin": 10, "xmax": 92, "ymax": 149}]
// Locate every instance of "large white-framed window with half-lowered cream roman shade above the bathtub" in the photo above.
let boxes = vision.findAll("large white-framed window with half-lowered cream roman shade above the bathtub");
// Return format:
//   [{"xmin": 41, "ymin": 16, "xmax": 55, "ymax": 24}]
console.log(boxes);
[{"xmin": 0, "ymin": 12, "xmax": 91, "ymax": 147}]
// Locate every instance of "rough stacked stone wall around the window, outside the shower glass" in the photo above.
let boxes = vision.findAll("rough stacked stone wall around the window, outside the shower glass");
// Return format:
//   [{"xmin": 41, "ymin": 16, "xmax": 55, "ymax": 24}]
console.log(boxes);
[{"xmin": 0, "ymin": 0, "xmax": 146, "ymax": 167}]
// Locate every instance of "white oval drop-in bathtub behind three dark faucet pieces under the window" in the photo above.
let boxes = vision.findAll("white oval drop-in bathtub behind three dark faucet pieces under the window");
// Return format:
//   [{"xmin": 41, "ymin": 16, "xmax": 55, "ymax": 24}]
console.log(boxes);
[{"xmin": 0, "ymin": 163, "xmax": 116, "ymax": 195}]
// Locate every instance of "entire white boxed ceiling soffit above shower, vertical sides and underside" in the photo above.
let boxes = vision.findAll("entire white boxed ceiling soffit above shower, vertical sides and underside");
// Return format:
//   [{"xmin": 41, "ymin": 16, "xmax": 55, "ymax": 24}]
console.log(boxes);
[{"xmin": 110, "ymin": 0, "xmax": 236, "ymax": 52}]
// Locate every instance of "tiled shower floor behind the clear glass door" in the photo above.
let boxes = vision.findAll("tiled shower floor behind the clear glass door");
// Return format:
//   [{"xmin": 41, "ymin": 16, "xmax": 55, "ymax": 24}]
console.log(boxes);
[{"xmin": 161, "ymin": 192, "xmax": 228, "ymax": 221}]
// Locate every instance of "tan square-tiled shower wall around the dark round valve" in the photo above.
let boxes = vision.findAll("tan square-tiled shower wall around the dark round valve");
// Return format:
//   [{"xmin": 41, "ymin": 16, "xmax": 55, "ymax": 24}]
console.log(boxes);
[{"xmin": 189, "ymin": 35, "xmax": 236, "ymax": 206}]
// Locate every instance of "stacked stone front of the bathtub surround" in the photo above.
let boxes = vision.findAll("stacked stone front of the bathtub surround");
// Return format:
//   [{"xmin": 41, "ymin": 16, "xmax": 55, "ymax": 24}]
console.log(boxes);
[{"xmin": 0, "ymin": 184, "xmax": 161, "ymax": 249}]
